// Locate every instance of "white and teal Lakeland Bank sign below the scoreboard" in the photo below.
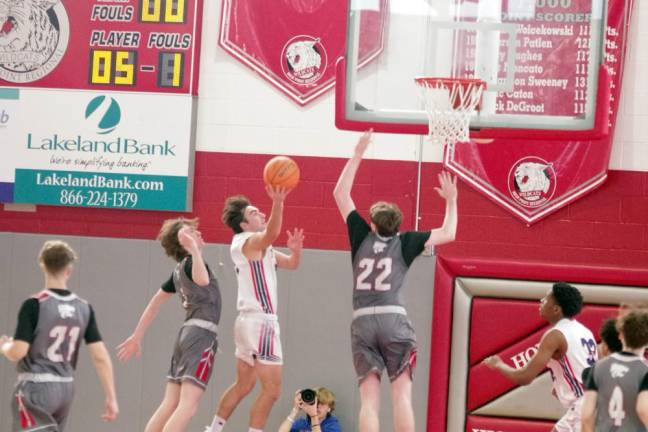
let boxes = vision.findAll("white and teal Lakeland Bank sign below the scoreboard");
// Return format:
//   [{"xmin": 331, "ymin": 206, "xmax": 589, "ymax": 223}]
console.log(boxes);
[{"xmin": 1, "ymin": 89, "xmax": 193, "ymax": 211}]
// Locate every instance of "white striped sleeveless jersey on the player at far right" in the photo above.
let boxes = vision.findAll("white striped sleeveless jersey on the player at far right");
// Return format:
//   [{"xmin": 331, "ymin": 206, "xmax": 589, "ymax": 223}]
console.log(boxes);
[{"xmin": 547, "ymin": 318, "xmax": 597, "ymax": 407}]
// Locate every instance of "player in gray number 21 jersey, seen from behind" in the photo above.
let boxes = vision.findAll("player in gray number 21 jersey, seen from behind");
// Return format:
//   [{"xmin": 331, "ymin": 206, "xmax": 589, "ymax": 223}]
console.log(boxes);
[{"xmin": 0, "ymin": 241, "xmax": 119, "ymax": 432}]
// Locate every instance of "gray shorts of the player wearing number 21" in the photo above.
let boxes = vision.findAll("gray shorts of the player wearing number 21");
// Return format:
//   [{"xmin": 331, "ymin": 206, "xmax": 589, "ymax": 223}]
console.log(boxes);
[{"xmin": 11, "ymin": 381, "xmax": 74, "ymax": 432}]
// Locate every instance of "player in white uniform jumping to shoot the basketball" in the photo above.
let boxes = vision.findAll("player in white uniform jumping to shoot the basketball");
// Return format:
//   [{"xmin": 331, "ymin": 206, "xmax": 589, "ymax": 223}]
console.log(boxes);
[{"xmin": 206, "ymin": 186, "xmax": 304, "ymax": 432}]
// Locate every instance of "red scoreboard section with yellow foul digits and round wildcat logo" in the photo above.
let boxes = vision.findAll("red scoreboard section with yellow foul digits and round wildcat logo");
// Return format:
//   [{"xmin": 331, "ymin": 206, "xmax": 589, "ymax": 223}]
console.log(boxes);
[{"xmin": 0, "ymin": 0, "xmax": 202, "ymax": 95}]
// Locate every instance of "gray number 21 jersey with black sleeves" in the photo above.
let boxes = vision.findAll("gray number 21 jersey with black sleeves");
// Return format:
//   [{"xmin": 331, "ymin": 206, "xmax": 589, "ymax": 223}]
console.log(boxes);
[{"xmin": 15, "ymin": 290, "xmax": 101, "ymax": 379}]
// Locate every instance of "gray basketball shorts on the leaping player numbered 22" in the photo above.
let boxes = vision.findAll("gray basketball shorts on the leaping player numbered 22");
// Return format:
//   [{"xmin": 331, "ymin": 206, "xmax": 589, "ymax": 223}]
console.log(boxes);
[{"xmin": 351, "ymin": 313, "xmax": 417, "ymax": 382}]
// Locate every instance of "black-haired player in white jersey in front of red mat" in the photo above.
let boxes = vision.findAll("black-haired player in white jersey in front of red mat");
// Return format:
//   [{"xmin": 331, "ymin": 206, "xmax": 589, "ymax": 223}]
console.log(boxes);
[{"xmin": 484, "ymin": 282, "xmax": 597, "ymax": 432}]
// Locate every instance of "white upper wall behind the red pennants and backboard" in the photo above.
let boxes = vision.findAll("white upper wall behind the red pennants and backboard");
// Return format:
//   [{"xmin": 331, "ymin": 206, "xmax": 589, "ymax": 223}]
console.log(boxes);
[{"xmin": 197, "ymin": 0, "xmax": 648, "ymax": 171}]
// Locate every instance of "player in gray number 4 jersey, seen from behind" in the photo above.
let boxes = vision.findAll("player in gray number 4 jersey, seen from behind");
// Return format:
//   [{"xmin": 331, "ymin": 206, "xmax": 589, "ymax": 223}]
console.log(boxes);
[{"xmin": 581, "ymin": 310, "xmax": 648, "ymax": 432}]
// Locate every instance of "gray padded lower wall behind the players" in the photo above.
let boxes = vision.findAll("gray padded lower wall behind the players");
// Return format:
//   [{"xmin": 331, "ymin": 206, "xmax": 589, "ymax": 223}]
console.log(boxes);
[{"xmin": 0, "ymin": 233, "xmax": 434, "ymax": 432}]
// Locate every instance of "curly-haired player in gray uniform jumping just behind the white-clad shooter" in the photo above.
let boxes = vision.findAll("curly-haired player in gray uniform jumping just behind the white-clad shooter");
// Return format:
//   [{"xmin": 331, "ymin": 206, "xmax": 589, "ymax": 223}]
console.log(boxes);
[{"xmin": 117, "ymin": 218, "xmax": 221, "ymax": 432}]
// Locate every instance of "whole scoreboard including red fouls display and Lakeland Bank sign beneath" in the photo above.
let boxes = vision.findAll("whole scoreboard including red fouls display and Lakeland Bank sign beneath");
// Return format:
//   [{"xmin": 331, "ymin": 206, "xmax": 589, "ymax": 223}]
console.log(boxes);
[{"xmin": 0, "ymin": 0, "xmax": 203, "ymax": 211}]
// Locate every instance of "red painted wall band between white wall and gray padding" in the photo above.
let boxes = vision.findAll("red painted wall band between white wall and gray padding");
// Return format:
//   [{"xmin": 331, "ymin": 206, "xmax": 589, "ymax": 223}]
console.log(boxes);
[{"xmin": 0, "ymin": 152, "xmax": 648, "ymax": 267}]
